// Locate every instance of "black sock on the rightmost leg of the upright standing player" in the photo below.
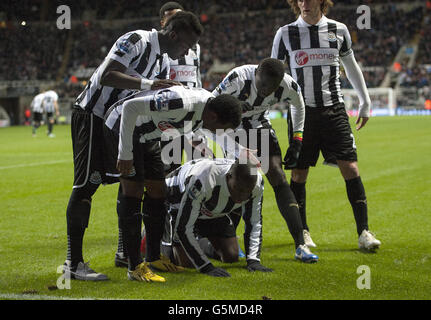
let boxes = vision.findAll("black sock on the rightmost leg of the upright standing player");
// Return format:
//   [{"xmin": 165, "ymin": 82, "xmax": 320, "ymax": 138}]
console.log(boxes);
[{"xmin": 346, "ymin": 177, "xmax": 368, "ymax": 235}]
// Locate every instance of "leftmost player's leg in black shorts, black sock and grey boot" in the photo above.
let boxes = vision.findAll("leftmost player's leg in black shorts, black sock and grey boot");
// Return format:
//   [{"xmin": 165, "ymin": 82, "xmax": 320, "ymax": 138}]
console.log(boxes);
[{"xmin": 65, "ymin": 109, "xmax": 108, "ymax": 281}]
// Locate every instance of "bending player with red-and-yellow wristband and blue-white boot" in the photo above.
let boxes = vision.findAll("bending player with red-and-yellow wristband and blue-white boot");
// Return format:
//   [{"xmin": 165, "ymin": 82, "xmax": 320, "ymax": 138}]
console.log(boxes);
[{"xmin": 213, "ymin": 58, "xmax": 318, "ymax": 262}]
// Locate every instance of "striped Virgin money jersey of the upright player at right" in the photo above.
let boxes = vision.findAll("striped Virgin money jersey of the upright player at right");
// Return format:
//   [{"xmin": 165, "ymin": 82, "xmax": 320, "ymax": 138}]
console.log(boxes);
[{"xmin": 271, "ymin": 16, "xmax": 353, "ymax": 107}]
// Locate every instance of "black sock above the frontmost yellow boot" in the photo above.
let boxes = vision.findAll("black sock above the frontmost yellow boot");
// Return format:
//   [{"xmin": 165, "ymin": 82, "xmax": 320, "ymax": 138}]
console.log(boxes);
[{"xmin": 143, "ymin": 195, "xmax": 166, "ymax": 262}]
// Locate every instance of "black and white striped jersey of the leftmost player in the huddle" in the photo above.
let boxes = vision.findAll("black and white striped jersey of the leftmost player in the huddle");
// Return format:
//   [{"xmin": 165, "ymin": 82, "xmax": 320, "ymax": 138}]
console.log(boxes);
[{"xmin": 76, "ymin": 30, "xmax": 169, "ymax": 118}]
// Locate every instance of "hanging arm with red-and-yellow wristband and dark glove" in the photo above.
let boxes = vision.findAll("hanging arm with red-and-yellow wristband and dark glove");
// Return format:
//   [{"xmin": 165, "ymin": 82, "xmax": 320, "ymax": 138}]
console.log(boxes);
[{"xmin": 284, "ymin": 75, "xmax": 305, "ymax": 169}]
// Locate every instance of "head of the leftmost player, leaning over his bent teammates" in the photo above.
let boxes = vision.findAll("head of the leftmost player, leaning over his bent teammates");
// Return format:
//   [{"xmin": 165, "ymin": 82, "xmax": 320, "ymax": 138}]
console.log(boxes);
[{"xmin": 159, "ymin": 11, "xmax": 204, "ymax": 60}]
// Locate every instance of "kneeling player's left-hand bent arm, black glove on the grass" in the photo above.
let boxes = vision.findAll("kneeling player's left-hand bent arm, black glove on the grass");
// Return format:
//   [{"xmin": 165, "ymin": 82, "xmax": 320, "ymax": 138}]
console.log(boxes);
[{"xmin": 174, "ymin": 178, "xmax": 230, "ymax": 277}]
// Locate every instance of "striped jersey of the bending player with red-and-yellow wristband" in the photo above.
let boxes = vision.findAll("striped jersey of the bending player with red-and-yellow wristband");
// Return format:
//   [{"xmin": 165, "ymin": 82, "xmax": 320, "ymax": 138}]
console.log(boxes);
[{"xmin": 213, "ymin": 65, "xmax": 305, "ymax": 132}]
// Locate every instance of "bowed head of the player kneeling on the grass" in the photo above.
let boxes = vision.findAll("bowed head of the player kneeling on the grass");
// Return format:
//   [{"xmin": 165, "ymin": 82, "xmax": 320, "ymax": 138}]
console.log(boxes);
[{"xmin": 226, "ymin": 160, "xmax": 257, "ymax": 203}]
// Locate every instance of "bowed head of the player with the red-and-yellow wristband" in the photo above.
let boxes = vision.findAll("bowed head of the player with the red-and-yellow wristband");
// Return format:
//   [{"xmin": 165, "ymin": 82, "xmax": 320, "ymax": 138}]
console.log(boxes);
[{"xmin": 256, "ymin": 58, "xmax": 284, "ymax": 97}]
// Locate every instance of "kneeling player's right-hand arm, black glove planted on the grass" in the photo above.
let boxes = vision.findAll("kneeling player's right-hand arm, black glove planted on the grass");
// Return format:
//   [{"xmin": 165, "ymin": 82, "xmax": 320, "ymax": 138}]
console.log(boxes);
[{"xmin": 242, "ymin": 179, "xmax": 272, "ymax": 272}]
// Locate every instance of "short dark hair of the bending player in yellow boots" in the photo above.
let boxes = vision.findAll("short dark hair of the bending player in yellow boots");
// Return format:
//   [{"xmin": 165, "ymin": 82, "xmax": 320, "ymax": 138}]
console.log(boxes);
[{"xmin": 208, "ymin": 94, "xmax": 242, "ymax": 128}]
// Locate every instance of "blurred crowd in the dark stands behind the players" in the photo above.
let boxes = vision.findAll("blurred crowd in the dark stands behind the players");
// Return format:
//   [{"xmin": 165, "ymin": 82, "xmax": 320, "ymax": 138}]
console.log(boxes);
[{"xmin": 0, "ymin": 0, "xmax": 431, "ymax": 100}]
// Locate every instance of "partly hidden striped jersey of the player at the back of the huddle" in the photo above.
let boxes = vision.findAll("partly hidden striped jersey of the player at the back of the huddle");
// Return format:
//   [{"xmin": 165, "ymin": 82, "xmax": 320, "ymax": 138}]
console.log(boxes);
[{"xmin": 169, "ymin": 44, "xmax": 202, "ymax": 88}]
